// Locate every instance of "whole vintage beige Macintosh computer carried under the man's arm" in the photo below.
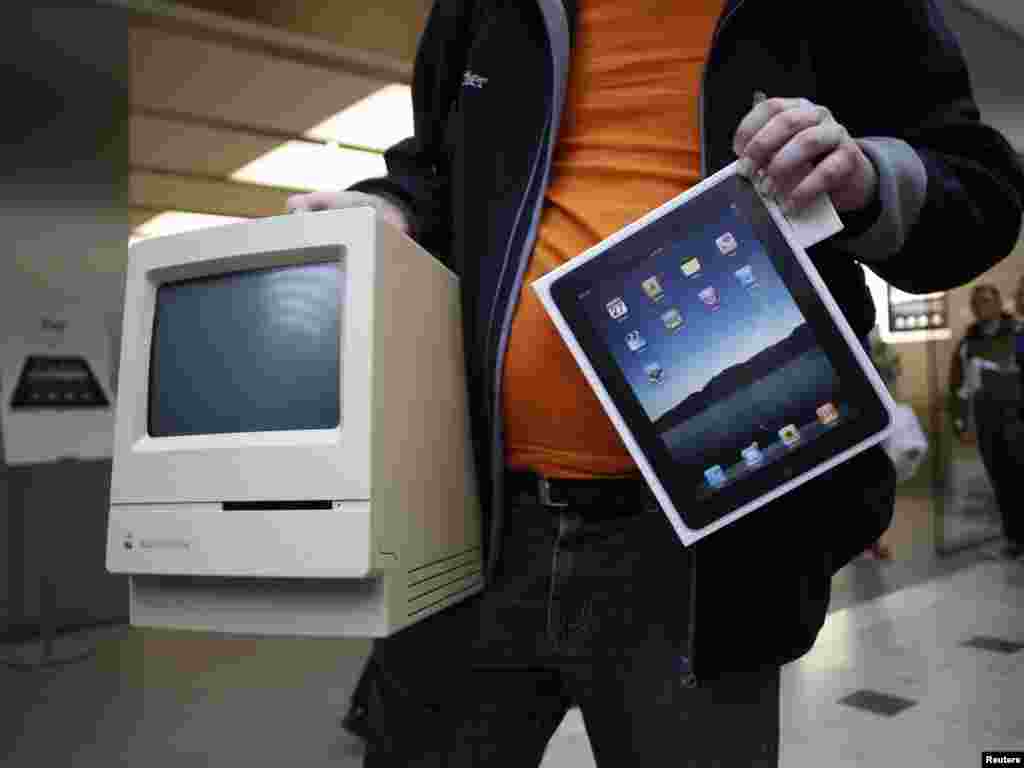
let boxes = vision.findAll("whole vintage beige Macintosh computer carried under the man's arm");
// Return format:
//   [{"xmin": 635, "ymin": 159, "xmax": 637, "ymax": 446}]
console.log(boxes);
[{"xmin": 106, "ymin": 208, "xmax": 482, "ymax": 637}]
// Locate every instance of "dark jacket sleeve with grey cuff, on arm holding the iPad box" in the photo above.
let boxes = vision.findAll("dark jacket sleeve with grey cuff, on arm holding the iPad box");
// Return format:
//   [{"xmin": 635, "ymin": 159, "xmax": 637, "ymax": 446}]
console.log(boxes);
[{"xmin": 812, "ymin": 0, "xmax": 1024, "ymax": 293}]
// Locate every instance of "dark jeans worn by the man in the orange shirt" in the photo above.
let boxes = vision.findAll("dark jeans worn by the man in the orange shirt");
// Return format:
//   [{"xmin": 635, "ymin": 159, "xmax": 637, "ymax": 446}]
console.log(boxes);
[{"xmin": 365, "ymin": 502, "xmax": 779, "ymax": 768}]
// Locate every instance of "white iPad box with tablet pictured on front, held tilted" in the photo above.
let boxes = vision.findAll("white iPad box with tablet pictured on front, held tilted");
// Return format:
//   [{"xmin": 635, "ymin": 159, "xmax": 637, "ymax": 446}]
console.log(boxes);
[{"xmin": 532, "ymin": 164, "xmax": 894, "ymax": 545}]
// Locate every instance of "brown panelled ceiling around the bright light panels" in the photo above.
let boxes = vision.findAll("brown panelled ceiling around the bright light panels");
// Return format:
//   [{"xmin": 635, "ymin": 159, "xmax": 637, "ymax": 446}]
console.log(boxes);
[{"xmin": 121, "ymin": 0, "xmax": 1024, "ymax": 237}]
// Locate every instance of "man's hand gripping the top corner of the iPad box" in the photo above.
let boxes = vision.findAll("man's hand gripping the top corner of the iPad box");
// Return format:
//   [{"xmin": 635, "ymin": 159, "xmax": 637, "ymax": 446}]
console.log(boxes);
[{"xmin": 732, "ymin": 98, "xmax": 879, "ymax": 217}]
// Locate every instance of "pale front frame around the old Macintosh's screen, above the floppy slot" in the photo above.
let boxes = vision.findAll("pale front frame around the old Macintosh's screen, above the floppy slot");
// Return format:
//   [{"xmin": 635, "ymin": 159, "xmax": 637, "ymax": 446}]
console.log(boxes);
[{"xmin": 112, "ymin": 208, "xmax": 377, "ymax": 512}]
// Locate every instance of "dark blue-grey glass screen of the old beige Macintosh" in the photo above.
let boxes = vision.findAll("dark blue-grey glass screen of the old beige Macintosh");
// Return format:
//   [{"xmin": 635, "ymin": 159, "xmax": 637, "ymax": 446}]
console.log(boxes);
[{"xmin": 148, "ymin": 261, "xmax": 343, "ymax": 437}]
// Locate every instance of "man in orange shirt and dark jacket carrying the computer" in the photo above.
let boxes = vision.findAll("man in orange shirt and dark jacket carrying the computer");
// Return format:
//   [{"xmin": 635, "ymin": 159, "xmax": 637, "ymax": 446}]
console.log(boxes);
[{"xmin": 290, "ymin": 0, "xmax": 1024, "ymax": 768}]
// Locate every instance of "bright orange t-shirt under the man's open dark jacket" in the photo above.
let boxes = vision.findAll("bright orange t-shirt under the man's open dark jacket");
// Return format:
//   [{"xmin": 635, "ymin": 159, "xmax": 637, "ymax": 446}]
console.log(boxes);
[{"xmin": 502, "ymin": 0, "xmax": 724, "ymax": 477}]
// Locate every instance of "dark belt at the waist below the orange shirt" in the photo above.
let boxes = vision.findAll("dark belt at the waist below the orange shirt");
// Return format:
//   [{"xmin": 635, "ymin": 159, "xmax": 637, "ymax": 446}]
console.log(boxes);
[{"xmin": 505, "ymin": 472, "xmax": 654, "ymax": 516}]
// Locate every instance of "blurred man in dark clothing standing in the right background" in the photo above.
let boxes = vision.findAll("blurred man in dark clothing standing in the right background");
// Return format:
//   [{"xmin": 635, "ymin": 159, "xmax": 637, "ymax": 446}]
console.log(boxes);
[{"xmin": 949, "ymin": 283, "xmax": 1024, "ymax": 558}]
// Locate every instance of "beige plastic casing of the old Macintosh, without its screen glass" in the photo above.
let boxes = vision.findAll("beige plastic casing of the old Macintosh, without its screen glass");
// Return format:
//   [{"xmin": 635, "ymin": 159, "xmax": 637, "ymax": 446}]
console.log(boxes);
[{"xmin": 106, "ymin": 207, "xmax": 482, "ymax": 637}]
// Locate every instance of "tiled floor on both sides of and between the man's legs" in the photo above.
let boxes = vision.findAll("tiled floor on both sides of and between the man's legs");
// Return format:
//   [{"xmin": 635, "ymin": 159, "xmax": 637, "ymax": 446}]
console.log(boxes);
[{"xmin": 0, "ymin": 499, "xmax": 1024, "ymax": 768}]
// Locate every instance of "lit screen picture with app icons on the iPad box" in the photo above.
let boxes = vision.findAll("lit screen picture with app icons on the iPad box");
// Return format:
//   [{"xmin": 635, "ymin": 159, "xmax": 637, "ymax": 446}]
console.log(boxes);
[{"xmin": 578, "ymin": 199, "xmax": 856, "ymax": 500}]
